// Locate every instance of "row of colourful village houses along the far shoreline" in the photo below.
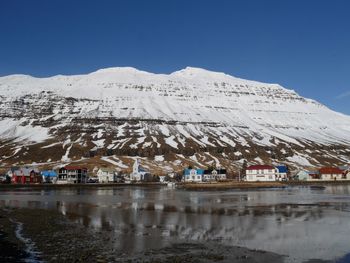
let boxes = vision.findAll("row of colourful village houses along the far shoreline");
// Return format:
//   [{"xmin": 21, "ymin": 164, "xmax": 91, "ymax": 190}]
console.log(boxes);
[{"xmin": 0, "ymin": 160, "xmax": 350, "ymax": 186}]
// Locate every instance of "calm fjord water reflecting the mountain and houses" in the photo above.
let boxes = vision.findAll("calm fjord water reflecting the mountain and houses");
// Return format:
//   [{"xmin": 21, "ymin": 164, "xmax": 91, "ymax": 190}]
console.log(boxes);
[{"xmin": 0, "ymin": 185, "xmax": 350, "ymax": 261}]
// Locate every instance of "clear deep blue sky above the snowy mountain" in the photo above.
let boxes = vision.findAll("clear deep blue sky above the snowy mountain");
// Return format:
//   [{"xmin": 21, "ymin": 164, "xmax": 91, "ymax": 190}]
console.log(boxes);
[{"xmin": 0, "ymin": 0, "xmax": 350, "ymax": 115}]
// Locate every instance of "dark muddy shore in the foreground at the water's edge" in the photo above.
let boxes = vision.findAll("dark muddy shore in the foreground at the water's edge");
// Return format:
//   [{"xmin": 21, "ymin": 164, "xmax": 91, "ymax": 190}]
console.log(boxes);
[{"xmin": 0, "ymin": 208, "xmax": 284, "ymax": 263}]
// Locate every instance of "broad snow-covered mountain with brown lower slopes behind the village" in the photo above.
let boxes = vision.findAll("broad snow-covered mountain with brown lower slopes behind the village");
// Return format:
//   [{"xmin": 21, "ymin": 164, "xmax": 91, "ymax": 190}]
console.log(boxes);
[{"xmin": 0, "ymin": 67, "xmax": 350, "ymax": 173}]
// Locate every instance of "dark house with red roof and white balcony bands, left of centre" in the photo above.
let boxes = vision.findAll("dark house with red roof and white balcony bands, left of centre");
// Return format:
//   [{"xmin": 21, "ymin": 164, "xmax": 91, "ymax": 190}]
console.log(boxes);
[{"xmin": 56, "ymin": 166, "xmax": 87, "ymax": 184}]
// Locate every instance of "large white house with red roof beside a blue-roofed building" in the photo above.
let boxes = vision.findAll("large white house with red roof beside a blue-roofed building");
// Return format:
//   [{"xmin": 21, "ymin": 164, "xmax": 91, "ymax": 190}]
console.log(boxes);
[{"xmin": 246, "ymin": 165, "xmax": 276, "ymax": 182}]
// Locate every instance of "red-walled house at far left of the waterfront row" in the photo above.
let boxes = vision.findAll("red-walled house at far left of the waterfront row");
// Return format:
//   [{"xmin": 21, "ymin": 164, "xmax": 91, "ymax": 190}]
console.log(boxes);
[{"xmin": 8, "ymin": 167, "xmax": 42, "ymax": 184}]
